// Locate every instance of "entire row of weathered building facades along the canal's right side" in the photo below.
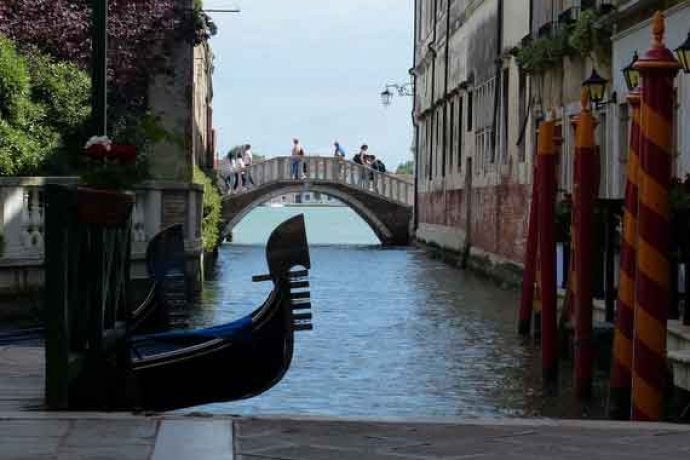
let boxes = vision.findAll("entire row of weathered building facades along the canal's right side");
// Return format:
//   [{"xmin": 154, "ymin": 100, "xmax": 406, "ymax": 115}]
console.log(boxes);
[{"xmin": 412, "ymin": 0, "xmax": 690, "ymax": 274}]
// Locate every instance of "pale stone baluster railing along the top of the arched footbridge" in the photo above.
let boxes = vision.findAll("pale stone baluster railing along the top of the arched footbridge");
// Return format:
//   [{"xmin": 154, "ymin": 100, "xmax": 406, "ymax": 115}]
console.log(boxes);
[{"xmin": 224, "ymin": 156, "xmax": 414, "ymax": 206}]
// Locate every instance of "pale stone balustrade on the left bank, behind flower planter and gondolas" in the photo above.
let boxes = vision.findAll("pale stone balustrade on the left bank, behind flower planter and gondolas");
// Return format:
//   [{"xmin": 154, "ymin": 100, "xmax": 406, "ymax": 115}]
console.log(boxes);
[{"xmin": 0, "ymin": 177, "xmax": 203, "ymax": 293}]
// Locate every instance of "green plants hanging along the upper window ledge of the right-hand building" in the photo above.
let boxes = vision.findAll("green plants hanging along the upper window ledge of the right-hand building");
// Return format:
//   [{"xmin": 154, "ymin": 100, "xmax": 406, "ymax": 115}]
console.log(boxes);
[{"xmin": 512, "ymin": 9, "xmax": 613, "ymax": 74}]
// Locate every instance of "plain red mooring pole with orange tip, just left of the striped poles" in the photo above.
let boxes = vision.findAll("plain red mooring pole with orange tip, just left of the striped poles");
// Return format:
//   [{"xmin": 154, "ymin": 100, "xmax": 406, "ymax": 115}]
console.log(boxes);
[{"xmin": 573, "ymin": 89, "xmax": 599, "ymax": 399}]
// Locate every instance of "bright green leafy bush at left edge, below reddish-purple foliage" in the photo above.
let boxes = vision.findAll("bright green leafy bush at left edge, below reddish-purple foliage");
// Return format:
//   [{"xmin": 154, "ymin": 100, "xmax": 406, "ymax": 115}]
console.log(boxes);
[{"xmin": 0, "ymin": 36, "xmax": 90, "ymax": 176}]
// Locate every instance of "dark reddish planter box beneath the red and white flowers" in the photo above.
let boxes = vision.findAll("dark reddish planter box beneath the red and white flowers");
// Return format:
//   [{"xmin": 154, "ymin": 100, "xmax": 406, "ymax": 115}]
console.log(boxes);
[{"xmin": 77, "ymin": 187, "xmax": 134, "ymax": 227}]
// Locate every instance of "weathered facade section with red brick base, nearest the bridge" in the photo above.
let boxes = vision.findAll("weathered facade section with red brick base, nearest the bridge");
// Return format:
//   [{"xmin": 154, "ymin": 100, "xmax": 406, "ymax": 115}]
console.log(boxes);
[{"xmin": 412, "ymin": 0, "xmax": 532, "ymax": 274}]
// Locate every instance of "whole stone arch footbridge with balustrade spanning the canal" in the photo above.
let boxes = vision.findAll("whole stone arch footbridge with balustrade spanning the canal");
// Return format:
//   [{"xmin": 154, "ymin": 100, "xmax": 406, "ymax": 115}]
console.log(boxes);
[{"xmin": 222, "ymin": 156, "xmax": 414, "ymax": 246}]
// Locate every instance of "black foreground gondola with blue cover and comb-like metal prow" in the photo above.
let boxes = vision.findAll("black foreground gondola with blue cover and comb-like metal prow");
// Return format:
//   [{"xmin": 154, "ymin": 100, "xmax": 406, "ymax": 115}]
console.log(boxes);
[{"xmin": 129, "ymin": 215, "xmax": 312, "ymax": 411}]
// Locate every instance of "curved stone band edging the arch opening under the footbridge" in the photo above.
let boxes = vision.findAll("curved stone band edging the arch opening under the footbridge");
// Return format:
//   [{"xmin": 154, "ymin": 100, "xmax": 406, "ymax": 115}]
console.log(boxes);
[{"xmin": 223, "ymin": 184, "xmax": 393, "ymax": 244}]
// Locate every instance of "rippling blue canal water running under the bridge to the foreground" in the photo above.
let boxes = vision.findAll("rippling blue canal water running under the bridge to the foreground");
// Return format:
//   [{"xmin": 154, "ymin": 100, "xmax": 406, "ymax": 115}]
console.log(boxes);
[{"xmin": 185, "ymin": 207, "xmax": 604, "ymax": 418}]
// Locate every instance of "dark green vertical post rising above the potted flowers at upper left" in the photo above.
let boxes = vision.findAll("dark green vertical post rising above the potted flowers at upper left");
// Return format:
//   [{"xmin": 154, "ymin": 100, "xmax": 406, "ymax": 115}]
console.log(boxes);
[{"xmin": 91, "ymin": 0, "xmax": 108, "ymax": 136}]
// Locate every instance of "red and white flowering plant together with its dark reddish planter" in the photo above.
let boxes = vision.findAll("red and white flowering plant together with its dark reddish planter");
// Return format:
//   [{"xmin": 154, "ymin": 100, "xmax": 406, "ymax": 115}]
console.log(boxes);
[{"xmin": 77, "ymin": 136, "xmax": 139, "ymax": 226}]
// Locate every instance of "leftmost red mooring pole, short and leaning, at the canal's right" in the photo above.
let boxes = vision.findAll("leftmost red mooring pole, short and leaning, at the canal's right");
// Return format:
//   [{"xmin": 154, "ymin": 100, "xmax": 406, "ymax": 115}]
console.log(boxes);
[{"xmin": 518, "ymin": 165, "xmax": 539, "ymax": 336}]
